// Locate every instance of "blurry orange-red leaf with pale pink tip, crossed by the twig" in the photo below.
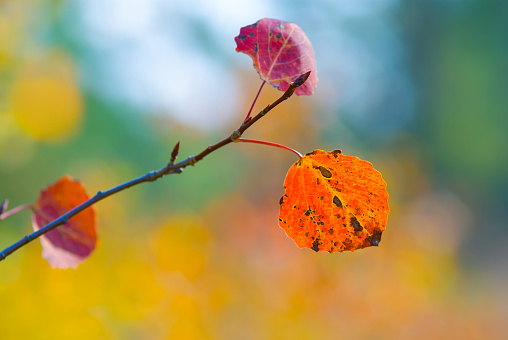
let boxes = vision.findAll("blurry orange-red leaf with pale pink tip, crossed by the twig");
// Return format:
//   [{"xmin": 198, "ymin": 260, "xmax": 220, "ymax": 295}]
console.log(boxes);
[{"xmin": 32, "ymin": 176, "xmax": 97, "ymax": 268}]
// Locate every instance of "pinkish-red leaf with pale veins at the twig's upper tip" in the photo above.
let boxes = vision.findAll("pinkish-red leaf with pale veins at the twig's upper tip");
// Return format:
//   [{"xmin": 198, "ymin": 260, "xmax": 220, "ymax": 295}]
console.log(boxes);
[{"xmin": 235, "ymin": 18, "xmax": 318, "ymax": 95}]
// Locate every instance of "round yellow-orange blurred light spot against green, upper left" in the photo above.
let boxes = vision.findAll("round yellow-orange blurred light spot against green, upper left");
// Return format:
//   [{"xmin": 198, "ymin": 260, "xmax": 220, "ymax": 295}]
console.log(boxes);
[{"xmin": 10, "ymin": 74, "xmax": 83, "ymax": 140}]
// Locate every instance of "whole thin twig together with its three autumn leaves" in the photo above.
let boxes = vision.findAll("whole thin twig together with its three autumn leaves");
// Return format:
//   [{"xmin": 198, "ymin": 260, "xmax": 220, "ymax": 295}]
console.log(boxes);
[{"xmin": 0, "ymin": 18, "xmax": 389, "ymax": 268}]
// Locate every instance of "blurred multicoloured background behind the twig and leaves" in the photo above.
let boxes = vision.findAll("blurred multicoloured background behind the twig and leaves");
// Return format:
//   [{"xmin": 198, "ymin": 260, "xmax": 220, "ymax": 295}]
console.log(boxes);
[{"xmin": 0, "ymin": 0, "xmax": 508, "ymax": 339}]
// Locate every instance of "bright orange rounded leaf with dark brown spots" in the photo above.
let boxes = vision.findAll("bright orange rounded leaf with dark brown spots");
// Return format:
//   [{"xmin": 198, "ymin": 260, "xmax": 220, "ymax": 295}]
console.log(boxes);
[{"xmin": 279, "ymin": 150, "xmax": 390, "ymax": 253}]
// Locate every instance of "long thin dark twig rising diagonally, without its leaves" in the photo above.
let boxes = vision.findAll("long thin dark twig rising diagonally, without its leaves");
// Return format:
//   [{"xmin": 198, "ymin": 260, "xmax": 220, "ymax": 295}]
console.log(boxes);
[{"xmin": 0, "ymin": 72, "xmax": 310, "ymax": 261}]
